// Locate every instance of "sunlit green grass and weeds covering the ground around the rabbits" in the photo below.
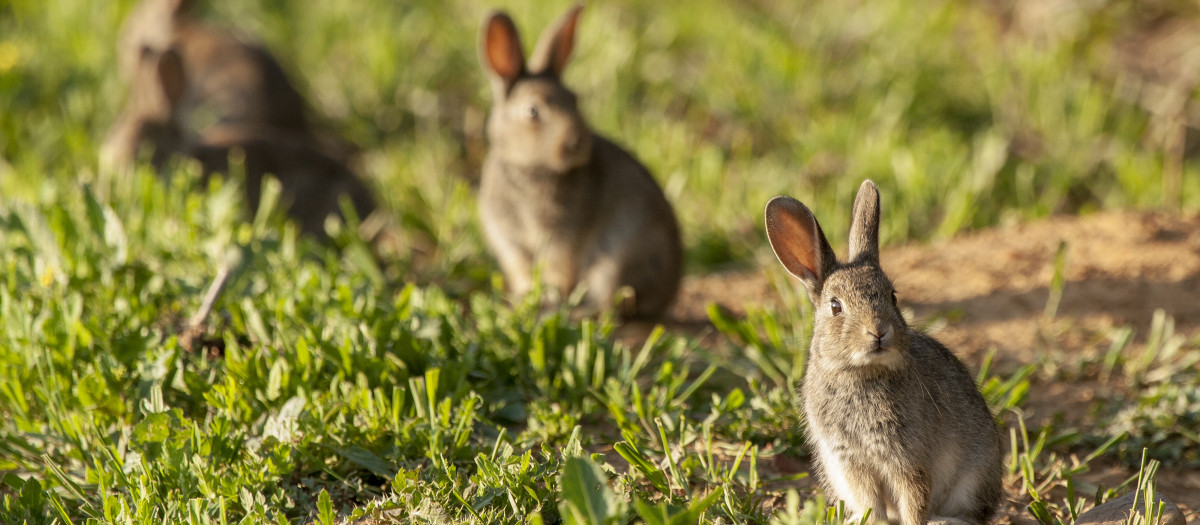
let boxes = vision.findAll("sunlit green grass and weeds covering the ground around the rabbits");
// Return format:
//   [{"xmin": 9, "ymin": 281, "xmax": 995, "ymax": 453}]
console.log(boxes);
[{"xmin": 0, "ymin": 0, "xmax": 1200, "ymax": 524}]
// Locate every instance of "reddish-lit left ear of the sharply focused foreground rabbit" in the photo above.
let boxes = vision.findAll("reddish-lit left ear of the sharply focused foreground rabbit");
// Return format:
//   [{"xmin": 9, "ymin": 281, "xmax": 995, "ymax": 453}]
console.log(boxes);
[{"xmin": 766, "ymin": 197, "xmax": 838, "ymax": 294}]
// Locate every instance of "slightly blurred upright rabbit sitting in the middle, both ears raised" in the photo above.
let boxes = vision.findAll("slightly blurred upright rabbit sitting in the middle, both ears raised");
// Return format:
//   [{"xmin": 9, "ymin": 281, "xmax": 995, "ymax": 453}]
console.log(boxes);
[{"xmin": 479, "ymin": 5, "xmax": 683, "ymax": 319}]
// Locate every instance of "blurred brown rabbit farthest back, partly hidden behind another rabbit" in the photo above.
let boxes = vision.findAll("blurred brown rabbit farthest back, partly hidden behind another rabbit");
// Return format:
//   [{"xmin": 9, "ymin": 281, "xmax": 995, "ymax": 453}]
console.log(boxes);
[{"xmin": 101, "ymin": 0, "xmax": 355, "ymax": 169}]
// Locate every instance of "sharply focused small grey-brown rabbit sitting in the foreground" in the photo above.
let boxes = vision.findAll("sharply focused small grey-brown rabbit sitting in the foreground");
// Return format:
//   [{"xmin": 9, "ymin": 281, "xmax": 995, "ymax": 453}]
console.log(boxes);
[{"xmin": 766, "ymin": 180, "xmax": 1002, "ymax": 525}]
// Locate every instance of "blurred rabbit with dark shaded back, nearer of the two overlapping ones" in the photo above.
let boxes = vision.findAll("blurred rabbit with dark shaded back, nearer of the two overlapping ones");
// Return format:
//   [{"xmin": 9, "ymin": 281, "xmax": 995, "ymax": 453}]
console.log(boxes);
[{"xmin": 107, "ymin": 48, "xmax": 376, "ymax": 237}]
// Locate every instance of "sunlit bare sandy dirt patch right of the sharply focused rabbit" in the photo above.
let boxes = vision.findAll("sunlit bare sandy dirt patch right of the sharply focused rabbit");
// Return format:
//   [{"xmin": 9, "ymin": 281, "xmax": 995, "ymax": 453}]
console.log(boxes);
[{"xmin": 883, "ymin": 212, "xmax": 1200, "ymax": 362}]
